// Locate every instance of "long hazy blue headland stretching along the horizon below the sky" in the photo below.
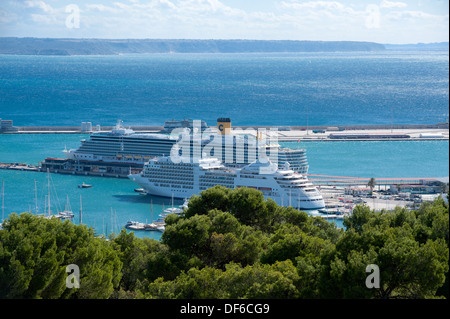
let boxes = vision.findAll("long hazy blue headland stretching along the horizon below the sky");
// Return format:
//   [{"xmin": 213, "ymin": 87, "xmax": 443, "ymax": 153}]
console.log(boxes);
[{"xmin": 0, "ymin": 37, "xmax": 386, "ymax": 55}]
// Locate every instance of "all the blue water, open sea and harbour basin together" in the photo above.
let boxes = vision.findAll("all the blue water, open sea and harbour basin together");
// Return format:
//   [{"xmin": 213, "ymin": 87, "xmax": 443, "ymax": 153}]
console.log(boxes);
[{"xmin": 0, "ymin": 51, "xmax": 449, "ymax": 239}]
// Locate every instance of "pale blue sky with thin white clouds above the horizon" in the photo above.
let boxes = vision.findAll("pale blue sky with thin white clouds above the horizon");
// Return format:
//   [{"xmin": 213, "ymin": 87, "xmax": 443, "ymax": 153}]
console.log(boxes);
[{"xmin": 0, "ymin": 0, "xmax": 449, "ymax": 44}]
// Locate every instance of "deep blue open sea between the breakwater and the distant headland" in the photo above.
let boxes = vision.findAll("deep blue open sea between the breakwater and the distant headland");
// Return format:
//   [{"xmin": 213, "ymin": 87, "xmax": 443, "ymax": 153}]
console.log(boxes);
[{"xmin": 0, "ymin": 51, "xmax": 449, "ymax": 126}]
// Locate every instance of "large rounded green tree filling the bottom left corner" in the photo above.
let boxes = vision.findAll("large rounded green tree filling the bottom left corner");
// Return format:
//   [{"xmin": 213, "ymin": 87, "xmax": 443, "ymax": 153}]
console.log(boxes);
[{"xmin": 0, "ymin": 213, "xmax": 122, "ymax": 299}]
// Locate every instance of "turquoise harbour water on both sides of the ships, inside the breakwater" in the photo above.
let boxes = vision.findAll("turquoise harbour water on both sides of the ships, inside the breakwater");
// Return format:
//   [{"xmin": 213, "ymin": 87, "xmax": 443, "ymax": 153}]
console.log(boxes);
[{"xmin": 0, "ymin": 134, "xmax": 449, "ymax": 239}]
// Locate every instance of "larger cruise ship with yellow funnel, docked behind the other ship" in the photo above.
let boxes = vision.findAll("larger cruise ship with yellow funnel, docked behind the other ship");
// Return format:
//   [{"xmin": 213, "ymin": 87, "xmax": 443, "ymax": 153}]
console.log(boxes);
[{"xmin": 64, "ymin": 121, "xmax": 309, "ymax": 174}]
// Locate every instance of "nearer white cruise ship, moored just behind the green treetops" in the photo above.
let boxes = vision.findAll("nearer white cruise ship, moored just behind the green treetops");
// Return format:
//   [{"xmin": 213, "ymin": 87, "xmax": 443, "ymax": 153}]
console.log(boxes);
[{"xmin": 128, "ymin": 157, "xmax": 325, "ymax": 210}]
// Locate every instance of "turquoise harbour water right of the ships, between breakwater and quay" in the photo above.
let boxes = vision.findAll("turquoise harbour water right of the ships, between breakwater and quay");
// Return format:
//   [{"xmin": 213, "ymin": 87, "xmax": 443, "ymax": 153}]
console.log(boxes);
[{"xmin": 280, "ymin": 141, "xmax": 449, "ymax": 178}]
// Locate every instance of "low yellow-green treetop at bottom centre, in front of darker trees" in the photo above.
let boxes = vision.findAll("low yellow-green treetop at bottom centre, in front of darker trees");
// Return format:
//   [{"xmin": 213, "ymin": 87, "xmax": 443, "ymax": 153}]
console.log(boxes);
[{"xmin": 144, "ymin": 261, "xmax": 298, "ymax": 299}]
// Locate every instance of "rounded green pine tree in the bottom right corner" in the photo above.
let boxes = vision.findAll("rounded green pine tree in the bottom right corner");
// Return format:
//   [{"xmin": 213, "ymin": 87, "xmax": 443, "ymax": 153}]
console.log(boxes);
[{"xmin": 326, "ymin": 215, "xmax": 449, "ymax": 298}]
